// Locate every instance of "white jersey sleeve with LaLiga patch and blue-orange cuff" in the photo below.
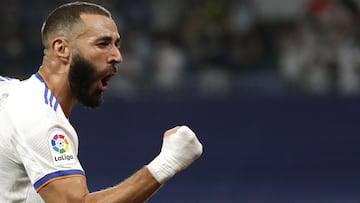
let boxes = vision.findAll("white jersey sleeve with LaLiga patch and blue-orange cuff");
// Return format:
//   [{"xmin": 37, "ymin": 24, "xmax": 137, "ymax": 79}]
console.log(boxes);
[{"xmin": 17, "ymin": 127, "xmax": 85, "ymax": 192}]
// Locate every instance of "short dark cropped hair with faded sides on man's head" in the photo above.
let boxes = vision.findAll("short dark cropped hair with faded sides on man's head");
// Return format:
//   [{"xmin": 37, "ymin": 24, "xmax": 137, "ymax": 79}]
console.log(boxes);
[{"xmin": 41, "ymin": 1, "xmax": 111, "ymax": 48}]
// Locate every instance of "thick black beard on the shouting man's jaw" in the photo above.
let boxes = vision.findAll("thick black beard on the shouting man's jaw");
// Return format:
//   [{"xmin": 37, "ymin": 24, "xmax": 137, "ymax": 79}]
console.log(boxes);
[{"xmin": 69, "ymin": 54, "xmax": 103, "ymax": 108}]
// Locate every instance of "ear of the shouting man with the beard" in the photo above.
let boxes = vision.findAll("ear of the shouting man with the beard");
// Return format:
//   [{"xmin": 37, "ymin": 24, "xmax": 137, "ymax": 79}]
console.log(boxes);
[{"xmin": 51, "ymin": 38, "xmax": 71, "ymax": 63}]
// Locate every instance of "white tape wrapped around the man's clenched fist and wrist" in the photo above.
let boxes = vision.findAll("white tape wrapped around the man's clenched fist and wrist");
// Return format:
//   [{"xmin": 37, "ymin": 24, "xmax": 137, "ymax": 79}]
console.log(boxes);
[{"xmin": 147, "ymin": 126, "xmax": 202, "ymax": 184}]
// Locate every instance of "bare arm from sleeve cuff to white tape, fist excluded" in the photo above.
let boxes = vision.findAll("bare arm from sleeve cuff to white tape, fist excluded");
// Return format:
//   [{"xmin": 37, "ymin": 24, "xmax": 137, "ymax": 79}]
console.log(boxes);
[{"xmin": 39, "ymin": 167, "xmax": 161, "ymax": 203}]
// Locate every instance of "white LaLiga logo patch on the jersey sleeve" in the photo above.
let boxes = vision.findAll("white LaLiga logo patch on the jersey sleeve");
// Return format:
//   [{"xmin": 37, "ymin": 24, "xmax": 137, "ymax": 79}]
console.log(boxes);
[{"xmin": 50, "ymin": 132, "xmax": 75, "ymax": 166}]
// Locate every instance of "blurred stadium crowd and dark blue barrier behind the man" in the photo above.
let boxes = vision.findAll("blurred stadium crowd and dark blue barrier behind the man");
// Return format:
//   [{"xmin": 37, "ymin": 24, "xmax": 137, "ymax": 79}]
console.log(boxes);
[{"xmin": 0, "ymin": 0, "xmax": 360, "ymax": 203}]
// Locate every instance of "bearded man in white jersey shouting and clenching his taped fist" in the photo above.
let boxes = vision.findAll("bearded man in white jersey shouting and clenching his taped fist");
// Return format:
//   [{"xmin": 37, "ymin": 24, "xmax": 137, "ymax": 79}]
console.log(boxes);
[{"xmin": 0, "ymin": 2, "xmax": 202, "ymax": 203}]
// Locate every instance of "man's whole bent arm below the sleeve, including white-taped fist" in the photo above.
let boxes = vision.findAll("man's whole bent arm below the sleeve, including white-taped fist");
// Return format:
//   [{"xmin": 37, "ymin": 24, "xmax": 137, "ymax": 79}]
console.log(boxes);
[{"xmin": 39, "ymin": 126, "xmax": 202, "ymax": 203}]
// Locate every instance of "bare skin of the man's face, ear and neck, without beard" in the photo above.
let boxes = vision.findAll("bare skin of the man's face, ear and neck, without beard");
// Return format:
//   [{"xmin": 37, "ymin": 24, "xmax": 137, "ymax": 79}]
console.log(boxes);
[{"xmin": 39, "ymin": 14, "xmax": 122, "ymax": 115}]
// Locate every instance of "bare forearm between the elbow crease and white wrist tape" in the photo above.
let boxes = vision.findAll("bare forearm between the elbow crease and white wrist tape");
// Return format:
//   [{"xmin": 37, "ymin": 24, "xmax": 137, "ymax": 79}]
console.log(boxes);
[{"xmin": 85, "ymin": 167, "xmax": 161, "ymax": 203}]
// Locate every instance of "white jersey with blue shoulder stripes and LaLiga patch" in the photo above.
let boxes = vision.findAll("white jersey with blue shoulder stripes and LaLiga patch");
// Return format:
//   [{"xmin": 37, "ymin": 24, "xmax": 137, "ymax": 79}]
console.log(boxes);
[{"xmin": 0, "ymin": 73, "xmax": 85, "ymax": 203}]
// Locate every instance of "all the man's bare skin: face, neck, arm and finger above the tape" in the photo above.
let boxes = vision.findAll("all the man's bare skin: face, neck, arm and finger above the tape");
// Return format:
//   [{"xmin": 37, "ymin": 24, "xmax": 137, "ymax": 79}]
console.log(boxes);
[{"xmin": 39, "ymin": 14, "xmax": 173, "ymax": 203}]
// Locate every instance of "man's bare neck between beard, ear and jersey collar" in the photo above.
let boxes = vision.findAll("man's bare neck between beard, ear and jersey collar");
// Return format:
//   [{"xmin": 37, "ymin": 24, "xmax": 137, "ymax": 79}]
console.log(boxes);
[{"xmin": 39, "ymin": 60, "xmax": 76, "ymax": 117}]
